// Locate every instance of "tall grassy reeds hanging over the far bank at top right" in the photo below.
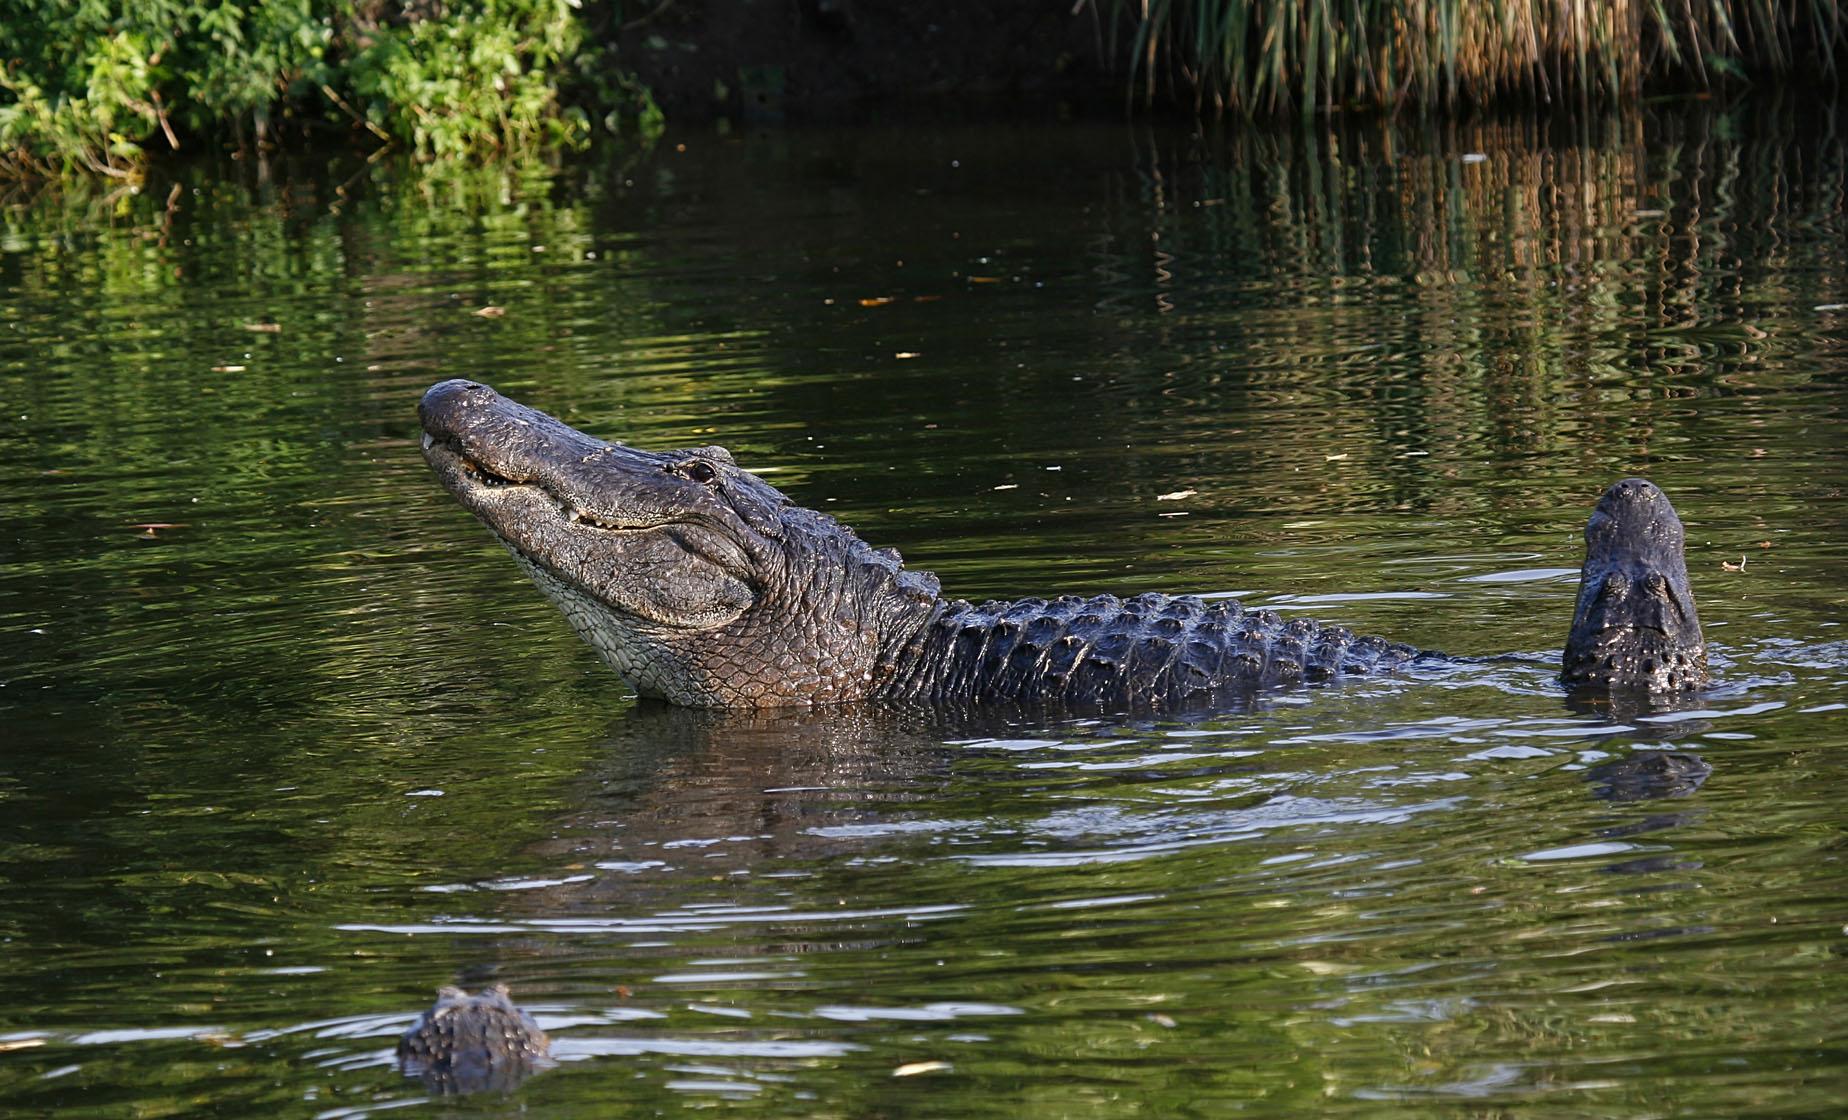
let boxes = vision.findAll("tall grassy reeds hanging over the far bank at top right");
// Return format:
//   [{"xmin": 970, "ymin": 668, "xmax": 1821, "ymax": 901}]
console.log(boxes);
[{"xmin": 1112, "ymin": 0, "xmax": 1848, "ymax": 113}]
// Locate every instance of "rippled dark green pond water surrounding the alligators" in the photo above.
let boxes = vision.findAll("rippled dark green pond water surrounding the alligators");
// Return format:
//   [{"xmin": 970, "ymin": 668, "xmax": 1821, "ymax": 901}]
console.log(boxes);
[{"xmin": 0, "ymin": 109, "xmax": 1848, "ymax": 1118}]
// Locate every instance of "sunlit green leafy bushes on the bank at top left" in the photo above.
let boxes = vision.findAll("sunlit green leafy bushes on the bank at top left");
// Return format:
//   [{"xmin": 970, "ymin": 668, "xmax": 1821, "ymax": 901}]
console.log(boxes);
[{"xmin": 0, "ymin": 0, "xmax": 613, "ymax": 177}]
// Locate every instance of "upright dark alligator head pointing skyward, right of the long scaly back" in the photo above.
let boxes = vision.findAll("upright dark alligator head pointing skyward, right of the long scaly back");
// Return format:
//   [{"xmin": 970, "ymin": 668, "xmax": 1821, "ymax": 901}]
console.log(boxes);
[{"xmin": 1560, "ymin": 479, "xmax": 1708, "ymax": 691}]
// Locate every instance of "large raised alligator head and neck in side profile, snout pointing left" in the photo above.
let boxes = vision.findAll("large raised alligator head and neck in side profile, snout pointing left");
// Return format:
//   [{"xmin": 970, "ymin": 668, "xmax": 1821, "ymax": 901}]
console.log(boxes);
[{"xmin": 418, "ymin": 381, "xmax": 937, "ymax": 708}]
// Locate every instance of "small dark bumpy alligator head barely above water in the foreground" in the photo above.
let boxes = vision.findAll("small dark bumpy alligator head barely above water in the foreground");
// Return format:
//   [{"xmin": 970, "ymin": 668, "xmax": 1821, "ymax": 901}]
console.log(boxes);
[{"xmin": 397, "ymin": 983, "xmax": 551, "ymax": 1094}]
